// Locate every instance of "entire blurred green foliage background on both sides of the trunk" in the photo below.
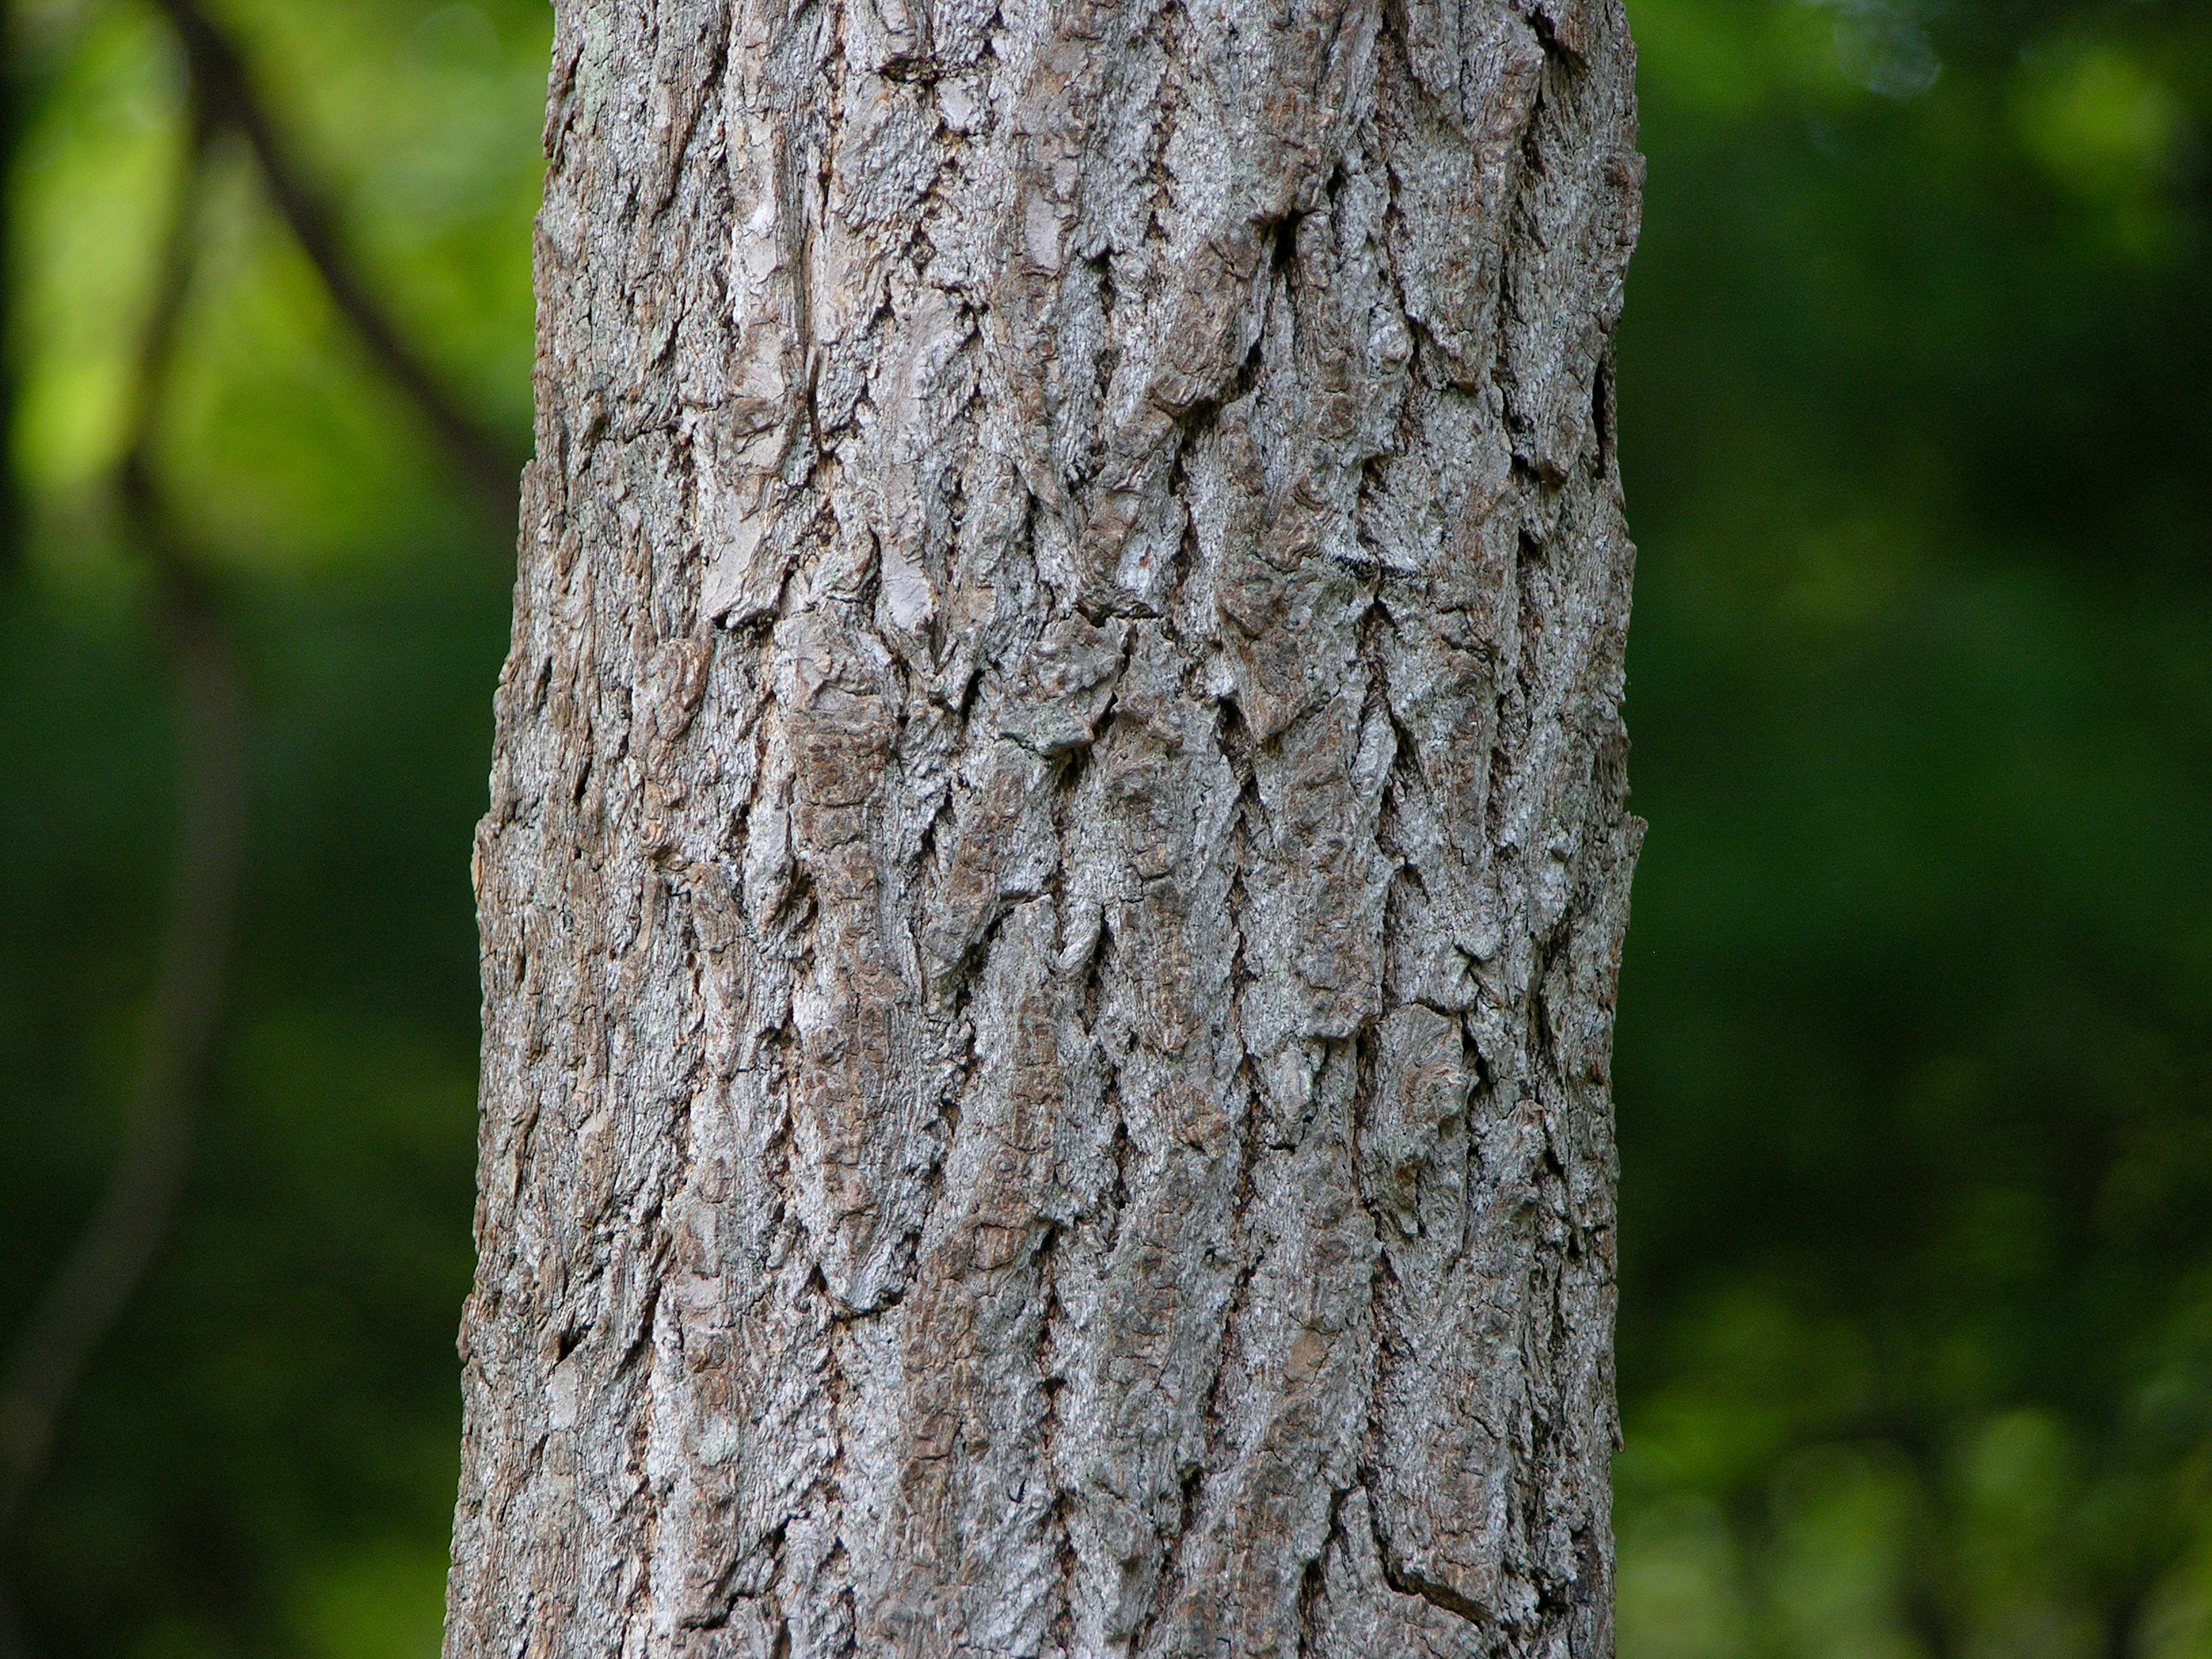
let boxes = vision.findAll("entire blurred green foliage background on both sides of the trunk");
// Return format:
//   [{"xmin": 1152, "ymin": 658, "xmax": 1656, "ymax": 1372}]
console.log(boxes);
[{"xmin": 0, "ymin": 0, "xmax": 2212, "ymax": 1659}]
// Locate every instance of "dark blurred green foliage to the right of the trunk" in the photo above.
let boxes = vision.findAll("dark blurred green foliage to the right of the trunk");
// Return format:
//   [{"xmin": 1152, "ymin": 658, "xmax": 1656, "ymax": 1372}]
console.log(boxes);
[{"xmin": 1617, "ymin": 0, "xmax": 2212, "ymax": 1659}]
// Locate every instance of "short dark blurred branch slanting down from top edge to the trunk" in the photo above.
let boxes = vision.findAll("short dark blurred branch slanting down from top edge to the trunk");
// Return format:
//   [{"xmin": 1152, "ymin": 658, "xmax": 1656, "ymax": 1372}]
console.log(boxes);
[{"xmin": 159, "ymin": 0, "xmax": 525, "ymax": 525}]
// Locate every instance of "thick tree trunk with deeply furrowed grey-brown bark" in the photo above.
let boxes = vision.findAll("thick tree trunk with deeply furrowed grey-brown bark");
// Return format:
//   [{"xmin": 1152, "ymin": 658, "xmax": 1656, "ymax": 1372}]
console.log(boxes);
[{"xmin": 447, "ymin": 0, "xmax": 1641, "ymax": 1659}]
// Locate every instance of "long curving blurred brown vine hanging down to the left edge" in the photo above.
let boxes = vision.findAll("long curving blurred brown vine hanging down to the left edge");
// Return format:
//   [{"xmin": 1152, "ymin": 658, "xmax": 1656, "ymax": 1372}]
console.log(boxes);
[{"xmin": 0, "ymin": 102, "xmax": 245, "ymax": 1548}]
